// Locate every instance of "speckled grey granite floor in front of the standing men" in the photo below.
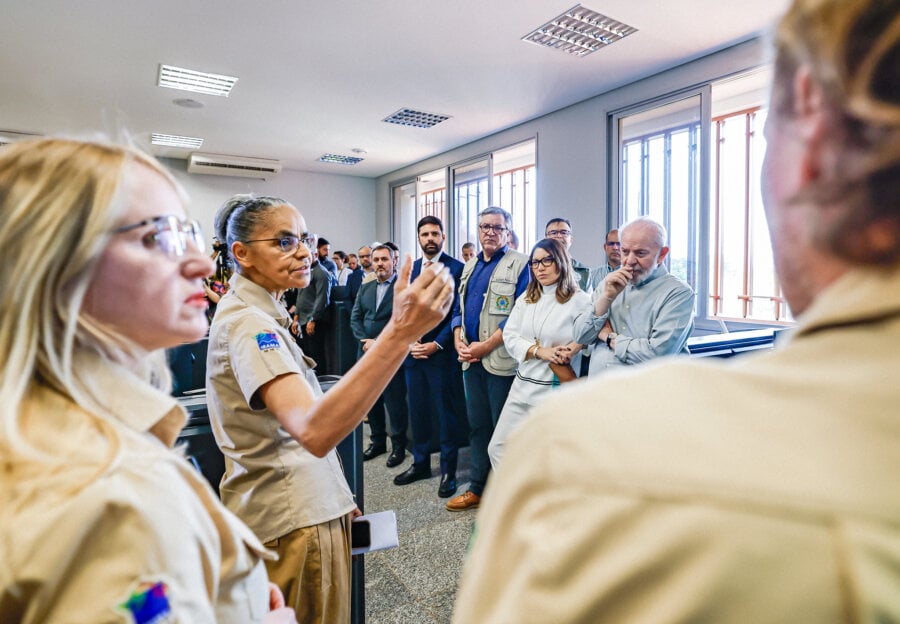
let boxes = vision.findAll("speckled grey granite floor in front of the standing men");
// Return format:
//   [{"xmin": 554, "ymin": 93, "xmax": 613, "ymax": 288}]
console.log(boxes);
[{"xmin": 363, "ymin": 427, "xmax": 476, "ymax": 624}]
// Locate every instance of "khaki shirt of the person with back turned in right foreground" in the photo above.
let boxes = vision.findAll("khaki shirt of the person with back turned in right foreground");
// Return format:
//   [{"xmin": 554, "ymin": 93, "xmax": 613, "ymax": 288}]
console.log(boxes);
[{"xmin": 454, "ymin": 269, "xmax": 900, "ymax": 624}]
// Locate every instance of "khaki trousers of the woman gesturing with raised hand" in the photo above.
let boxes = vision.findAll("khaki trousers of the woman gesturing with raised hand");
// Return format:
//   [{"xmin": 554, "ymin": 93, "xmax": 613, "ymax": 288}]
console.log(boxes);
[{"xmin": 265, "ymin": 514, "xmax": 351, "ymax": 624}]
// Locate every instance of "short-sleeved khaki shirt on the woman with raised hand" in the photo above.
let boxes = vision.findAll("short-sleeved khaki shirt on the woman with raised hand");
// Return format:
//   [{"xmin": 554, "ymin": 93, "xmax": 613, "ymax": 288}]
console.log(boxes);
[{"xmin": 206, "ymin": 274, "xmax": 356, "ymax": 542}]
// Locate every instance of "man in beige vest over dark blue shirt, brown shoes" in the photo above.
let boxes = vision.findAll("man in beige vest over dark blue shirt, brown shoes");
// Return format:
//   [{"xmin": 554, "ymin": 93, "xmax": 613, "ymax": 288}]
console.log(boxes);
[{"xmin": 447, "ymin": 208, "xmax": 530, "ymax": 511}]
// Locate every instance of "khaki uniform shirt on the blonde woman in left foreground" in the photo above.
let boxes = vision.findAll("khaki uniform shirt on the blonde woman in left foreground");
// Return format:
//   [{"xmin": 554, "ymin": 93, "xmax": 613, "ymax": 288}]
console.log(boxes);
[{"xmin": 0, "ymin": 364, "xmax": 269, "ymax": 624}]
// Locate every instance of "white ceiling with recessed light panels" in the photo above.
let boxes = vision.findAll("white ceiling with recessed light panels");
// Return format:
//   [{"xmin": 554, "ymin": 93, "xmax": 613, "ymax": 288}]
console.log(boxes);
[{"xmin": 0, "ymin": 0, "xmax": 787, "ymax": 177}]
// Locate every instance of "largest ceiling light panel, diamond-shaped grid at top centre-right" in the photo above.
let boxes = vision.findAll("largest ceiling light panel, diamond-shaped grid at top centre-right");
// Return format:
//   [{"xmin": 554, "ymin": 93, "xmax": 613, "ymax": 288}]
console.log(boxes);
[{"xmin": 522, "ymin": 4, "xmax": 637, "ymax": 56}]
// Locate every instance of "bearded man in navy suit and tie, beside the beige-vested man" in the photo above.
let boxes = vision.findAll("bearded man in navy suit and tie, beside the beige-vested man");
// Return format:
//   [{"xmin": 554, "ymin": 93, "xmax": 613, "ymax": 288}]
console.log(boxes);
[{"xmin": 394, "ymin": 216, "xmax": 467, "ymax": 498}]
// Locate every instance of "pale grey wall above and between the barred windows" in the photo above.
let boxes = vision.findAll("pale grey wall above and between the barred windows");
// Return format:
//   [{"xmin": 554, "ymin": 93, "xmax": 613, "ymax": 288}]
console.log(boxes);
[{"xmin": 375, "ymin": 39, "xmax": 766, "ymax": 266}]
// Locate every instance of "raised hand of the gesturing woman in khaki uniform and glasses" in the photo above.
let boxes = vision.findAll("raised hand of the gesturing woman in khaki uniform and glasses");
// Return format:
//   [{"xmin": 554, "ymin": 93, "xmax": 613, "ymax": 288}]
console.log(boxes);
[{"xmin": 385, "ymin": 254, "xmax": 455, "ymax": 344}]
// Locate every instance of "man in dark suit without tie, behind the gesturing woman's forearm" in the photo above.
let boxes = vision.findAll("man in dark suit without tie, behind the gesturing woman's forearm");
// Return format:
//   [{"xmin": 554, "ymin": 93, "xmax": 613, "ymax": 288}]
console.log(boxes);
[{"xmin": 350, "ymin": 245, "xmax": 409, "ymax": 466}]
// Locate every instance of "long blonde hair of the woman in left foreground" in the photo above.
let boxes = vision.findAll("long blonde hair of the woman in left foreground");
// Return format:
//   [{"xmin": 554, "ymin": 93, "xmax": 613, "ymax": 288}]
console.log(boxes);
[{"xmin": 0, "ymin": 139, "xmax": 178, "ymax": 461}]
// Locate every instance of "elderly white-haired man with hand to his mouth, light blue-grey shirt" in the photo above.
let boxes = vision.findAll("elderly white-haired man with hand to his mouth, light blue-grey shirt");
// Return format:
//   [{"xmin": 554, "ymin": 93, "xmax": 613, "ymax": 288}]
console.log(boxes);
[{"xmin": 575, "ymin": 217, "xmax": 694, "ymax": 375}]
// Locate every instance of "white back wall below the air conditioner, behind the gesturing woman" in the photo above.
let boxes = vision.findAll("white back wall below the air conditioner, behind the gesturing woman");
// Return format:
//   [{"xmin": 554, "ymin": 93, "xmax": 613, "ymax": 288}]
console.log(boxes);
[{"xmin": 161, "ymin": 159, "xmax": 375, "ymax": 253}]
